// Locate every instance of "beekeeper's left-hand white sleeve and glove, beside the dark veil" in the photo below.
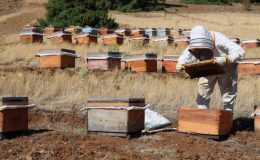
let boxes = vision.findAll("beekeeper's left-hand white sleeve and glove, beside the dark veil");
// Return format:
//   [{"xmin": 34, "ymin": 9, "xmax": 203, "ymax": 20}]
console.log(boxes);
[{"xmin": 176, "ymin": 47, "xmax": 197, "ymax": 72}]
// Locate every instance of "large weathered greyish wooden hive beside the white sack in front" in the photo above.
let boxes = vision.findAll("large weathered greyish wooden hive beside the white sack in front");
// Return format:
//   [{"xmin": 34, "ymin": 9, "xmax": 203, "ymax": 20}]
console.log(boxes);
[{"xmin": 87, "ymin": 98, "xmax": 145, "ymax": 137}]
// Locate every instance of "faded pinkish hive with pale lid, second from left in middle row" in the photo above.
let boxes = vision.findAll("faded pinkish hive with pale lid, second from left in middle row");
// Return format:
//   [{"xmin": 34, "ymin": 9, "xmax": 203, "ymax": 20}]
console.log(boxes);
[{"xmin": 86, "ymin": 52, "xmax": 121, "ymax": 71}]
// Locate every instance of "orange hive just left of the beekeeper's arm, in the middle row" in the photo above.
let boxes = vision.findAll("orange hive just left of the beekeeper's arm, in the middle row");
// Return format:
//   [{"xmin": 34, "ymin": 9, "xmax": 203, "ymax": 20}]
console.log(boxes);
[{"xmin": 162, "ymin": 55, "xmax": 180, "ymax": 73}]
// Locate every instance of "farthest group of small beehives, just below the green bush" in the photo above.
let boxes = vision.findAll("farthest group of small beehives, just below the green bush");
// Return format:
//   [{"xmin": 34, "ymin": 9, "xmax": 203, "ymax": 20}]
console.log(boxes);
[{"xmin": 20, "ymin": 27, "xmax": 260, "ymax": 48}]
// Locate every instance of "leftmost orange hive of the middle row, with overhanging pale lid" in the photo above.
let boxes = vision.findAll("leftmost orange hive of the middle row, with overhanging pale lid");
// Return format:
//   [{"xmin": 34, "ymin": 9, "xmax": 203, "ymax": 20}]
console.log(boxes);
[{"xmin": 36, "ymin": 49, "xmax": 79, "ymax": 69}]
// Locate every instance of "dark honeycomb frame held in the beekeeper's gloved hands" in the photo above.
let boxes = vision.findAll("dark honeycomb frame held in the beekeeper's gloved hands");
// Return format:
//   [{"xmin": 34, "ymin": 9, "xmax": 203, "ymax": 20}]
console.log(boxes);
[{"xmin": 184, "ymin": 59, "xmax": 225, "ymax": 78}]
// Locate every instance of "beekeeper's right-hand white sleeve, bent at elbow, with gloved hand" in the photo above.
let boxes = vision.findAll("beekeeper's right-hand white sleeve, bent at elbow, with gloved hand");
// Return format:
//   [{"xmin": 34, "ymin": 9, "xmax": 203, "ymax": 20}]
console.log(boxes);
[{"xmin": 215, "ymin": 32, "xmax": 245, "ymax": 66}]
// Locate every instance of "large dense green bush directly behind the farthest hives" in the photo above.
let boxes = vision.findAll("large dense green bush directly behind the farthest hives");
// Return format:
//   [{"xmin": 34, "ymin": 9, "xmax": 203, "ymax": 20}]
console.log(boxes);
[{"xmin": 38, "ymin": 0, "xmax": 118, "ymax": 28}]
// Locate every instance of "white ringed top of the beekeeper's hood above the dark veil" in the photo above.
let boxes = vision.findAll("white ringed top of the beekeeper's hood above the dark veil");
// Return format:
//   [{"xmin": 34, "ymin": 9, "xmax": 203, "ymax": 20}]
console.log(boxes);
[{"xmin": 189, "ymin": 26, "xmax": 215, "ymax": 50}]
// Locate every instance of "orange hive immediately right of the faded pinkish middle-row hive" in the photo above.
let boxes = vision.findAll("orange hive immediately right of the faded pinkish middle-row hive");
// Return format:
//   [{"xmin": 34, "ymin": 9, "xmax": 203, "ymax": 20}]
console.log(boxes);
[{"xmin": 123, "ymin": 53, "xmax": 157, "ymax": 72}]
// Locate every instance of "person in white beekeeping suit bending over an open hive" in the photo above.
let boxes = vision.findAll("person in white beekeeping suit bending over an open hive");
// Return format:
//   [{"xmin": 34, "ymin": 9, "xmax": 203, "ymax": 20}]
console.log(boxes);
[{"xmin": 176, "ymin": 26, "xmax": 245, "ymax": 111}]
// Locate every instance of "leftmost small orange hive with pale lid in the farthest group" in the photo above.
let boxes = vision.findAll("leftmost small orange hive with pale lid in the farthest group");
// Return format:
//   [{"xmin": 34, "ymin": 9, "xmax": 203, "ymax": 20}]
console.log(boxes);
[{"xmin": 20, "ymin": 27, "xmax": 43, "ymax": 43}]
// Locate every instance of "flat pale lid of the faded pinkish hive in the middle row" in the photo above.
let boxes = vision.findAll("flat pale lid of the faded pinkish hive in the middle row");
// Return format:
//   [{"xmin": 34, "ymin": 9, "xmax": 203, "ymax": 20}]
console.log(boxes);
[{"xmin": 87, "ymin": 52, "xmax": 121, "ymax": 59}]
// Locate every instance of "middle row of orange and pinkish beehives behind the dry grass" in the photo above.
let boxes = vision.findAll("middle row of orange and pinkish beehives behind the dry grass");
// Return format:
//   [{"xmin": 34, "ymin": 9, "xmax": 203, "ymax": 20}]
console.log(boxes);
[{"xmin": 36, "ymin": 49, "xmax": 260, "ymax": 74}]
